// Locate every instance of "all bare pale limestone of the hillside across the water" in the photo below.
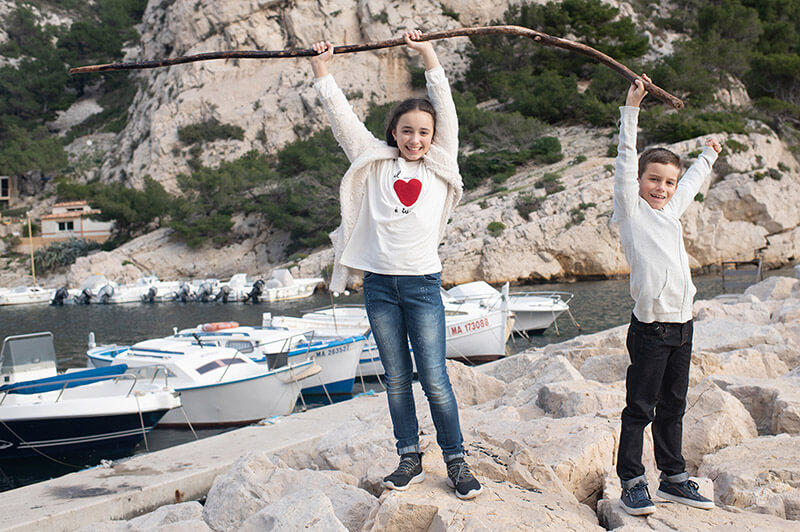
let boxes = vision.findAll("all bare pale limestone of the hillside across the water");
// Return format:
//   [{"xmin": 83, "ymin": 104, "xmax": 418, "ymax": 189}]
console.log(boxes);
[{"xmin": 0, "ymin": 0, "xmax": 800, "ymax": 285}]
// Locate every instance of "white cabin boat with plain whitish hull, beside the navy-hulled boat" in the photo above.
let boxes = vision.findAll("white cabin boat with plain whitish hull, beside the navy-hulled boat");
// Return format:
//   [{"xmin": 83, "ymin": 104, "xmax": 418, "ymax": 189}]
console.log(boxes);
[{"xmin": 87, "ymin": 336, "xmax": 319, "ymax": 426}]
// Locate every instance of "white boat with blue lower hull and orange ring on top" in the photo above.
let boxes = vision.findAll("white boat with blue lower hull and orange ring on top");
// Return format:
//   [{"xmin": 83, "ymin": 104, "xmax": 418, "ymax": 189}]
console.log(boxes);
[{"xmin": 169, "ymin": 322, "xmax": 366, "ymax": 395}]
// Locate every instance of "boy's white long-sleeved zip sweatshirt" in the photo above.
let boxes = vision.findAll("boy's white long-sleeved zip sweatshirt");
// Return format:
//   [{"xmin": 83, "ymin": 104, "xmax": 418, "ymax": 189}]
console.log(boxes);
[{"xmin": 612, "ymin": 106, "xmax": 717, "ymax": 323}]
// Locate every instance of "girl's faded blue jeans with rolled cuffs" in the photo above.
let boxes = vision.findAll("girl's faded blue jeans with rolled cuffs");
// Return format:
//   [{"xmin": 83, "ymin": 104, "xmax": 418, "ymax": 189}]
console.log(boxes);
[{"xmin": 364, "ymin": 272, "xmax": 464, "ymax": 461}]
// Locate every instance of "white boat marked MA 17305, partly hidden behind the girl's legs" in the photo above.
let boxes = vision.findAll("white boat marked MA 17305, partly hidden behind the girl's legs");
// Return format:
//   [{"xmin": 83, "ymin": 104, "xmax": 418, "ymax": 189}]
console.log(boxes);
[{"xmin": 262, "ymin": 291, "xmax": 513, "ymax": 376}]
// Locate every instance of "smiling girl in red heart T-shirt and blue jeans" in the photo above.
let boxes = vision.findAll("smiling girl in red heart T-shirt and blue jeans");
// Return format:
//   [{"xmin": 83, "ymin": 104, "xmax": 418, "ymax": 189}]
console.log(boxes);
[{"xmin": 311, "ymin": 30, "xmax": 482, "ymax": 499}]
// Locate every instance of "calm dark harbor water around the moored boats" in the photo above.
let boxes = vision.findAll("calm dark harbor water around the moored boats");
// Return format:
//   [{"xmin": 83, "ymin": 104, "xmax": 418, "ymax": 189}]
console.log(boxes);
[{"xmin": 0, "ymin": 270, "xmax": 793, "ymax": 491}]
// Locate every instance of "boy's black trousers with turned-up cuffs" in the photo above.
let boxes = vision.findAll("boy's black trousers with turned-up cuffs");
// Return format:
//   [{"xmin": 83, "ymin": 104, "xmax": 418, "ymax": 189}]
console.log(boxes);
[{"xmin": 617, "ymin": 315, "xmax": 693, "ymax": 482}]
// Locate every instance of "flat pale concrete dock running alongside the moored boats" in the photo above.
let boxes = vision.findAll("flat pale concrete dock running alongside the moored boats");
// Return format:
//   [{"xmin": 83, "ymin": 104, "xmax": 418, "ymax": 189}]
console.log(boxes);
[{"xmin": 0, "ymin": 393, "xmax": 386, "ymax": 532}]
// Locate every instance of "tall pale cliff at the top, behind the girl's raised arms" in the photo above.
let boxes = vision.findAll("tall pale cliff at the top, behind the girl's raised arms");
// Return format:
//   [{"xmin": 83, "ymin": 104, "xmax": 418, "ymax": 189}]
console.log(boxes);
[{"xmin": 102, "ymin": 0, "xmax": 490, "ymax": 191}]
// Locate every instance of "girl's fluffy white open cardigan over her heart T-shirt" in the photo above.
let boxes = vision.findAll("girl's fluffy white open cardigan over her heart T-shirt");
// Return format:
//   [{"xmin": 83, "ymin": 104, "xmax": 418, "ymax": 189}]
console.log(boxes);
[{"xmin": 314, "ymin": 67, "xmax": 463, "ymax": 292}]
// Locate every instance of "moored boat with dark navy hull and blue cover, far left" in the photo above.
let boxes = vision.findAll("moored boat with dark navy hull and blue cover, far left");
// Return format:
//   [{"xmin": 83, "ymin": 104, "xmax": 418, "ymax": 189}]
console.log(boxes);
[{"xmin": 0, "ymin": 332, "xmax": 181, "ymax": 459}]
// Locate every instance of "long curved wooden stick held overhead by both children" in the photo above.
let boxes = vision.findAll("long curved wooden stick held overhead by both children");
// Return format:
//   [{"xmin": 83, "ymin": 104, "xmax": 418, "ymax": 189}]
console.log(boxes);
[{"xmin": 69, "ymin": 26, "xmax": 683, "ymax": 109}]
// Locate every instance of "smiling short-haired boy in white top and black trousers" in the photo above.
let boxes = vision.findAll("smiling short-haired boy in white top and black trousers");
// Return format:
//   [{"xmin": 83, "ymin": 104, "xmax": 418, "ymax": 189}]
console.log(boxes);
[{"xmin": 613, "ymin": 75, "xmax": 722, "ymax": 515}]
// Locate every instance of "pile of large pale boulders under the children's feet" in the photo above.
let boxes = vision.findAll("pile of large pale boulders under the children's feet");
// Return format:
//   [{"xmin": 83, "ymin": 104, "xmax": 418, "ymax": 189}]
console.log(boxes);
[{"xmin": 70, "ymin": 277, "xmax": 800, "ymax": 532}]
